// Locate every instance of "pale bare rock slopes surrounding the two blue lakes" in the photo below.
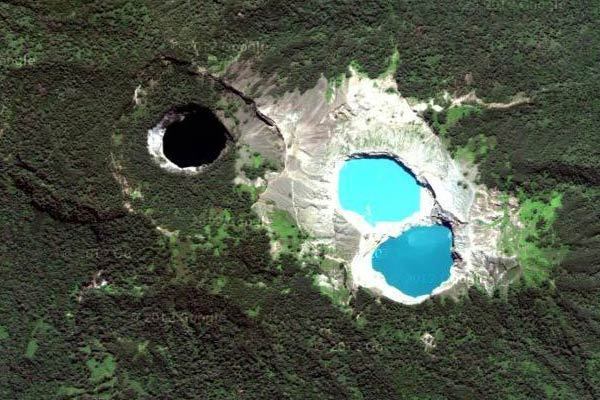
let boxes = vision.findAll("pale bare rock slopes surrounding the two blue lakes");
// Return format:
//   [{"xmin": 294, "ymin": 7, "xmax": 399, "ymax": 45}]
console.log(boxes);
[{"xmin": 223, "ymin": 65, "xmax": 516, "ymax": 303}]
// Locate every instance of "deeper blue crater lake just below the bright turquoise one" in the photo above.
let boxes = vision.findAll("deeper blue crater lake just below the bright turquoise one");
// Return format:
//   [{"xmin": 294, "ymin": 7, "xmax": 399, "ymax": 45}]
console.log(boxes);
[{"xmin": 371, "ymin": 225, "xmax": 452, "ymax": 297}]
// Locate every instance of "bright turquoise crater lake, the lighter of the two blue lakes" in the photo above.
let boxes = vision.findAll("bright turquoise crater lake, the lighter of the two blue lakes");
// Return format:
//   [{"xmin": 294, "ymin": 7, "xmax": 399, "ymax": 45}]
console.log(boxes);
[{"xmin": 338, "ymin": 157, "xmax": 421, "ymax": 226}]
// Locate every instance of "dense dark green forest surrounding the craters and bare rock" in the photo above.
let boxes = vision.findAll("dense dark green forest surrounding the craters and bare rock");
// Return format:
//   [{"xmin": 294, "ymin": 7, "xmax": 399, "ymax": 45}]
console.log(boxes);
[{"xmin": 0, "ymin": 0, "xmax": 600, "ymax": 399}]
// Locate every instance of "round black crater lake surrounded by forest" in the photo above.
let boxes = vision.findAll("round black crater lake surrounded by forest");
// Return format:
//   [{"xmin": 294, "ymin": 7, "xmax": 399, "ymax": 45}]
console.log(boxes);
[{"xmin": 163, "ymin": 104, "xmax": 230, "ymax": 168}]
